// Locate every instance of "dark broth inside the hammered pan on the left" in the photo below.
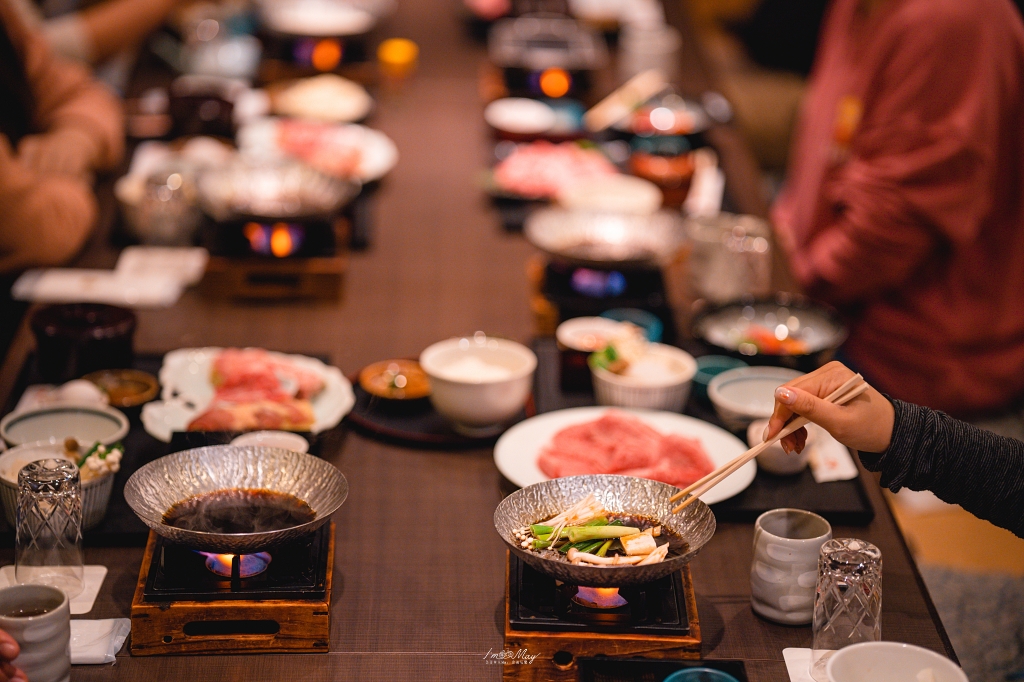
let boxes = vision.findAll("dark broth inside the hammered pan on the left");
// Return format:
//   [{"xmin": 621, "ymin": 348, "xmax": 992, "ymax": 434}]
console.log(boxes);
[{"xmin": 164, "ymin": 488, "xmax": 316, "ymax": 534}]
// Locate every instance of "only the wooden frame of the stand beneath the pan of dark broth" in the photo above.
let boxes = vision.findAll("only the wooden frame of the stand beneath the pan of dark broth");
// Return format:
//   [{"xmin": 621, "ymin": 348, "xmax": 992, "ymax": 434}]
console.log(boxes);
[{"xmin": 130, "ymin": 521, "xmax": 334, "ymax": 656}]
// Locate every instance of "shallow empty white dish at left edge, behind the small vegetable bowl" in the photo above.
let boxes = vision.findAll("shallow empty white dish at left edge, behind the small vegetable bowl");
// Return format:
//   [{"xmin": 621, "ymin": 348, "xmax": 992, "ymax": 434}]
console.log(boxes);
[{"xmin": 0, "ymin": 403, "xmax": 128, "ymax": 445}]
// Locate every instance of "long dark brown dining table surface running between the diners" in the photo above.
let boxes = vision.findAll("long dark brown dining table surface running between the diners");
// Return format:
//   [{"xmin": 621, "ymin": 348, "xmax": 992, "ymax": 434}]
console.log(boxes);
[{"xmin": 0, "ymin": 0, "xmax": 954, "ymax": 682}]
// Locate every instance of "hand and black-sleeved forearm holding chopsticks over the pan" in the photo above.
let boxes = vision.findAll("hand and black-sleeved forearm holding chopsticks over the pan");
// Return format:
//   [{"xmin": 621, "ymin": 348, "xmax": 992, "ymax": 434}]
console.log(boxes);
[{"xmin": 765, "ymin": 363, "xmax": 1024, "ymax": 538}]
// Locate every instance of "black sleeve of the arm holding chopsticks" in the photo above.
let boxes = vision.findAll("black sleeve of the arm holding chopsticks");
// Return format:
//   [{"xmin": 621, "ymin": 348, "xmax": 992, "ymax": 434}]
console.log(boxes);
[{"xmin": 860, "ymin": 396, "xmax": 1024, "ymax": 538}]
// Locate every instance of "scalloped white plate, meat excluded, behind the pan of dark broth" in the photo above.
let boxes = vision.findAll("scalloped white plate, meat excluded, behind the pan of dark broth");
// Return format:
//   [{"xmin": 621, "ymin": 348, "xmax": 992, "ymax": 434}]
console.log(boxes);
[{"xmin": 142, "ymin": 347, "xmax": 355, "ymax": 442}]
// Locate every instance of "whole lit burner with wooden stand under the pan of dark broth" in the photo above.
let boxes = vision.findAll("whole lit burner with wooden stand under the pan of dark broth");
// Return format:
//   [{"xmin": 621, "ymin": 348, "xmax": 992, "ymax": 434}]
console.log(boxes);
[{"xmin": 131, "ymin": 522, "xmax": 334, "ymax": 655}]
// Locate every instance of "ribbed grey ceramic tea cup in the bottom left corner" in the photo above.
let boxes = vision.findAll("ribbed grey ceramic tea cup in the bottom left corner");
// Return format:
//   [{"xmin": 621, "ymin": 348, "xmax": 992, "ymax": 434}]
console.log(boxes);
[{"xmin": 0, "ymin": 585, "xmax": 71, "ymax": 682}]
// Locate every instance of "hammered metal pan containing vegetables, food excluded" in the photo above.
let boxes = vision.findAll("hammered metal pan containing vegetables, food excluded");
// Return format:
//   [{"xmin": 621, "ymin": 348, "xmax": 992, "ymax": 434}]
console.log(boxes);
[{"xmin": 495, "ymin": 474, "xmax": 715, "ymax": 587}]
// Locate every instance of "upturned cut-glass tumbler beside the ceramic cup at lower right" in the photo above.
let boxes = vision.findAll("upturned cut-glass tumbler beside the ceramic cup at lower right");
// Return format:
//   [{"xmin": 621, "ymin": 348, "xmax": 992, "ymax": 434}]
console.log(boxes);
[{"xmin": 810, "ymin": 538, "xmax": 882, "ymax": 682}]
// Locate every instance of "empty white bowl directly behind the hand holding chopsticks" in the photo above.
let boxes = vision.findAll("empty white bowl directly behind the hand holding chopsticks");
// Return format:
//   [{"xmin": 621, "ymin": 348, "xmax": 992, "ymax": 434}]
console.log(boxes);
[{"xmin": 708, "ymin": 367, "xmax": 803, "ymax": 431}]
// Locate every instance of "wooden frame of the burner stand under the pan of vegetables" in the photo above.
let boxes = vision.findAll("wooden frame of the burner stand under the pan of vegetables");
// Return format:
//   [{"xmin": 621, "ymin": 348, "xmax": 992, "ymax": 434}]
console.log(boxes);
[{"xmin": 502, "ymin": 561, "xmax": 700, "ymax": 682}]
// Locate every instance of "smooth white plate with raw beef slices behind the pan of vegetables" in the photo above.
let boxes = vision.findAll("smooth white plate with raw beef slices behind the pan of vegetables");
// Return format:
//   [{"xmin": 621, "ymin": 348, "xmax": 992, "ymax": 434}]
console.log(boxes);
[{"xmin": 495, "ymin": 408, "xmax": 757, "ymax": 504}]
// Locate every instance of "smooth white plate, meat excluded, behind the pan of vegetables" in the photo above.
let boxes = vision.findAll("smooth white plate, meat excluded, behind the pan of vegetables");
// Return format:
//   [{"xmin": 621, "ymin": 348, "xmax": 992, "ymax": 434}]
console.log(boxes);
[{"xmin": 495, "ymin": 408, "xmax": 757, "ymax": 505}]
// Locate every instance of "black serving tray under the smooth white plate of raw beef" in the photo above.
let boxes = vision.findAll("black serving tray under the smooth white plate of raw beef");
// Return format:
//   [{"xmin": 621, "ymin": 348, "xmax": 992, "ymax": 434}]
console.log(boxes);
[{"xmin": 534, "ymin": 338, "xmax": 874, "ymax": 525}]
